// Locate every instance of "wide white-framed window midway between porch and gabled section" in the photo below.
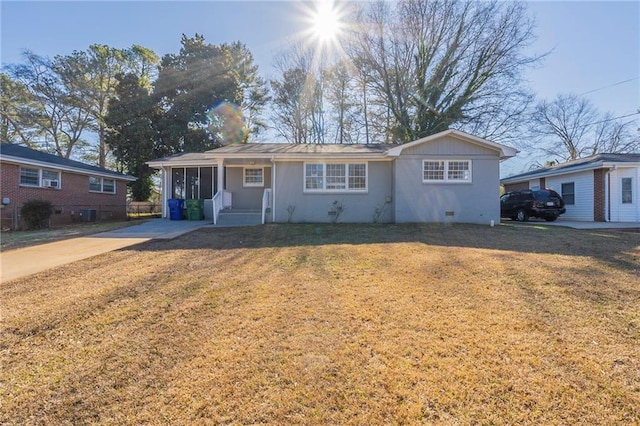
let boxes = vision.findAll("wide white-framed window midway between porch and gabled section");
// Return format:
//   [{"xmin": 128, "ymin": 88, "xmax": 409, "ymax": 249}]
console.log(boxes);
[{"xmin": 304, "ymin": 163, "xmax": 367, "ymax": 191}]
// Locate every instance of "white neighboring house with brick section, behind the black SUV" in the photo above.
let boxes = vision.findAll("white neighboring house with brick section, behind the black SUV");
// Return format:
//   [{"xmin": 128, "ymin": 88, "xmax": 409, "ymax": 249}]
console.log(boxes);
[{"xmin": 500, "ymin": 154, "xmax": 640, "ymax": 222}]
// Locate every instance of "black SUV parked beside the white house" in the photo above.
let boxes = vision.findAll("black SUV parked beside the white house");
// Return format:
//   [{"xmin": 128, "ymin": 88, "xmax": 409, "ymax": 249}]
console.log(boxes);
[{"xmin": 500, "ymin": 189, "xmax": 567, "ymax": 222}]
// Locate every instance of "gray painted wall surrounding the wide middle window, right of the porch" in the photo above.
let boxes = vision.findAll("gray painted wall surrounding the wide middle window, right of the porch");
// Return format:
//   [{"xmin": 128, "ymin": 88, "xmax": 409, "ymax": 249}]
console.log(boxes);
[{"xmin": 273, "ymin": 161, "xmax": 393, "ymax": 223}]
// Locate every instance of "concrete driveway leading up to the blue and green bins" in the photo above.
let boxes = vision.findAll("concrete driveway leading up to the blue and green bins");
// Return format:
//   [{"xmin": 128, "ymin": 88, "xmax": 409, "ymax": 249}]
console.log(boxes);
[{"xmin": 0, "ymin": 219, "xmax": 213, "ymax": 283}]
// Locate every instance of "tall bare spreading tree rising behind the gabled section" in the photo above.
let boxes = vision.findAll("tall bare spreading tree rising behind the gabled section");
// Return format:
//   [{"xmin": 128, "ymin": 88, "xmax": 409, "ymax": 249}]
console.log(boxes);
[{"xmin": 349, "ymin": 0, "xmax": 538, "ymax": 142}]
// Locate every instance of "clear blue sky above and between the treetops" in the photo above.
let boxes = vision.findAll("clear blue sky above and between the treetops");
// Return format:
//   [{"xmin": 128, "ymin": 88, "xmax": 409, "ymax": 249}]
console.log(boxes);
[{"xmin": 0, "ymin": 0, "xmax": 640, "ymax": 175}]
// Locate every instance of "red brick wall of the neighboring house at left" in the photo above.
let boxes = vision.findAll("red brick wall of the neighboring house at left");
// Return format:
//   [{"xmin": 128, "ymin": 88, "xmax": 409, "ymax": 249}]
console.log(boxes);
[{"xmin": 0, "ymin": 163, "xmax": 127, "ymax": 229}]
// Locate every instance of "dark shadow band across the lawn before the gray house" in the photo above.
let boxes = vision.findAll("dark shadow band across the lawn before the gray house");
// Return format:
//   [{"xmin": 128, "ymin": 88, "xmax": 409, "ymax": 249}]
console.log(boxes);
[{"xmin": 123, "ymin": 224, "xmax": 640, "ymax": 271}]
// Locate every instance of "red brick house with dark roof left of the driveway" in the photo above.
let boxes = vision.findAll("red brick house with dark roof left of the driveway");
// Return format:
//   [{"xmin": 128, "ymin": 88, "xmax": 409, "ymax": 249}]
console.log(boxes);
[{"xmin": 0, "ymin": 143, "xmax": 135, "ymax": 229}]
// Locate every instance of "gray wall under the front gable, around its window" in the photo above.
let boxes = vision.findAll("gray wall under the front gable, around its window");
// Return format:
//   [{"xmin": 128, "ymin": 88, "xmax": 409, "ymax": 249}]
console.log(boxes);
[{"xmin": 395, "ymin": 153, "xmax": 500, "ymax": 224}]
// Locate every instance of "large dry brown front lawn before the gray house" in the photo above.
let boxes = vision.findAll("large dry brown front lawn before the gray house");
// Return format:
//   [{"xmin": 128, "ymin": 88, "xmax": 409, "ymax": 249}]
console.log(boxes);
[{"xmin": 0, "ymin": 225, "xmax": 640, "ymax": 425}]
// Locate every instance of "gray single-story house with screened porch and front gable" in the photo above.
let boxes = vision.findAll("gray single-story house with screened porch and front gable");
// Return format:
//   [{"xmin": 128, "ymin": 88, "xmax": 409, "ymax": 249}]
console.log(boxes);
[{"xmin": 148, "ymin": 130, "xmax": 517, "ymax": 224}]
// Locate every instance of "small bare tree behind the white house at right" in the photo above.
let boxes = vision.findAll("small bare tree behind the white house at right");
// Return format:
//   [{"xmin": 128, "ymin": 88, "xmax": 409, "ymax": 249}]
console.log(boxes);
[{"xmin": 530, "ymin": 94, "xmax": 640, "ymax": 161}]
